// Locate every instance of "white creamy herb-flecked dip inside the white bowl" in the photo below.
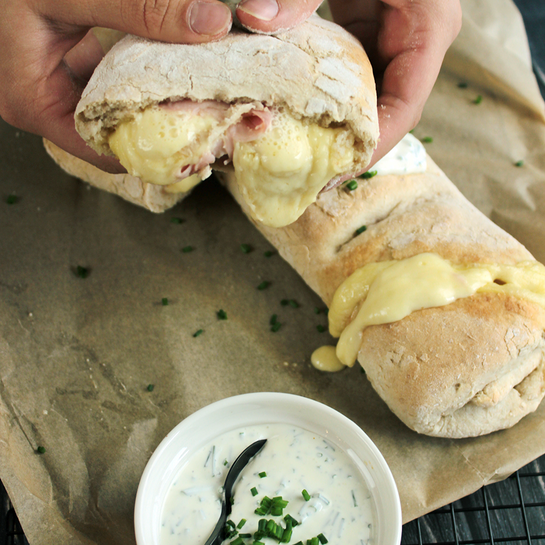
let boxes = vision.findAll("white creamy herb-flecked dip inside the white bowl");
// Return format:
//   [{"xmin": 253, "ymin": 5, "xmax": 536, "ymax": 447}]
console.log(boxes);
[{"xmin": 160, "ymin": 424, "xmax": 376, "ymax": 545}]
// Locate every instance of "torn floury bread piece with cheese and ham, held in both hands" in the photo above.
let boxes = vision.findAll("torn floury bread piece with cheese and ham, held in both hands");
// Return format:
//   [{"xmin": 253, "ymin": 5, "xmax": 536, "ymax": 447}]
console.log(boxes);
[{"xmin": 75, "ymin": 16, "xmax": 378, "ymax": 226}]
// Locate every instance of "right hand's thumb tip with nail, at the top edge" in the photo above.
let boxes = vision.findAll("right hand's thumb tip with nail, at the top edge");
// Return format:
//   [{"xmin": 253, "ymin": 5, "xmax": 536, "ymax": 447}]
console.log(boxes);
[{"xmin": 237, "ymin": 0, "xmax": 322, "ymax": 34}]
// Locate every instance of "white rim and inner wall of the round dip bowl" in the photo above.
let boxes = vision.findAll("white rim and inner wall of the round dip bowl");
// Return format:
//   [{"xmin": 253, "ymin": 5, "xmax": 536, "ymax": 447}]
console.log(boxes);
[{"xmin": 134, "ymin": 392, "xmax": 402, "ymax": 545}]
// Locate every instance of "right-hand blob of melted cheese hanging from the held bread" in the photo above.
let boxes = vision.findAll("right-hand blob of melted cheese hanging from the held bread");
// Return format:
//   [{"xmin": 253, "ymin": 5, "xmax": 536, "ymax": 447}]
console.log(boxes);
[{"xmin": 233, "ymin": 114, "xmax": 354, "ymax": 227}]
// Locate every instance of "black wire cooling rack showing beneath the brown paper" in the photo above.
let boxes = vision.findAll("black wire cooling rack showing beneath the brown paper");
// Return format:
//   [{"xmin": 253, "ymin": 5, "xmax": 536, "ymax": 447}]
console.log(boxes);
[{"xmin": 0, "ymin": 455, "xmax": 545, "ymax": 545}]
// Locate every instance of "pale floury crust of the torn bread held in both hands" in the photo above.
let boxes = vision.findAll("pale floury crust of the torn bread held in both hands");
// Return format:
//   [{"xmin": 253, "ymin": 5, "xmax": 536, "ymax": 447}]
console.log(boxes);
[{"xmin": 75, "ymin": 16, "xmax": 378, "ymax": 169}]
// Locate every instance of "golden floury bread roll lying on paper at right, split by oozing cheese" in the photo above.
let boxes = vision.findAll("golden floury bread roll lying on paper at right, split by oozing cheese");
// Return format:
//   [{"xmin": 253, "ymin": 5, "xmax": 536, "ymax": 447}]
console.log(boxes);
[{"xmin": 222, "ymin": 158, "xmax": 545, "ymax": 438}]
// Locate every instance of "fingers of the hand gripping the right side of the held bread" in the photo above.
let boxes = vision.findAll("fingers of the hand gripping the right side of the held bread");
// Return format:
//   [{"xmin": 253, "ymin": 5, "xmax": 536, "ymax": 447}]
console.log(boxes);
[{"xmin": 329, "ymin": 0, "xmax": 462, "ymax": 166}]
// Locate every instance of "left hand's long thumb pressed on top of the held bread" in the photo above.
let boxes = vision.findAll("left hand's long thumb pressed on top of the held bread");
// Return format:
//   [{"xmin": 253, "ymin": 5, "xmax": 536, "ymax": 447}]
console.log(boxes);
[{"xmin": 34, "ymin": 0, "xmax": 232, "ymax": 43}]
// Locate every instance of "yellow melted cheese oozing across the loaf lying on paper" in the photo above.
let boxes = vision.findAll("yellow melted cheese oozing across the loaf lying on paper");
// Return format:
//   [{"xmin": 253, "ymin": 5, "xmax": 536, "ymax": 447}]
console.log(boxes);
[{"xmin": 318, "ymin": 253, "xmax": 545, "ymax": 366}]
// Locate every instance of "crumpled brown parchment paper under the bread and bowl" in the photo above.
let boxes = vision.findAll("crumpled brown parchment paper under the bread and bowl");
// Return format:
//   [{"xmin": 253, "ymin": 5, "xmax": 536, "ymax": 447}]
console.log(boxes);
[{"xmin": 0, "ymin": 0, "xmax": 545, "ymax": 545}]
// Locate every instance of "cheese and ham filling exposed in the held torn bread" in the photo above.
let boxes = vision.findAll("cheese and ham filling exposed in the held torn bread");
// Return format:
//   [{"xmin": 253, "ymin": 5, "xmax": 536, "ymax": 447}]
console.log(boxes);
[{"xmin": 109, "ymin": 100, "xmax": 355, "ymax": 227}]
